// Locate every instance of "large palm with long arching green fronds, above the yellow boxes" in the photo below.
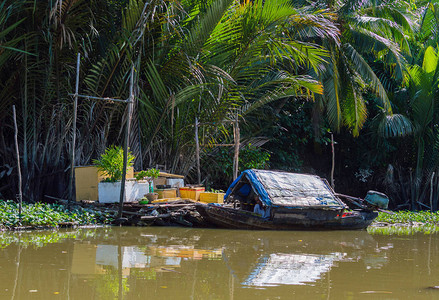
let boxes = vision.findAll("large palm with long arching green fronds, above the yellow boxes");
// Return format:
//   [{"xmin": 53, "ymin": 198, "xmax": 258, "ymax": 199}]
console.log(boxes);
[{"xmin": 134, "ymin": 1, "xmax": 334, "ymax": 174}]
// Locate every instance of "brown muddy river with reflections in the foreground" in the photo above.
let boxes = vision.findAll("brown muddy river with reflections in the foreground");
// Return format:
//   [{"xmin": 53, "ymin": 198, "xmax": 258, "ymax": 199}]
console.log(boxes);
[{"xmin": 0, "ymin": 227, "xmax": 439, "ymax": 300}]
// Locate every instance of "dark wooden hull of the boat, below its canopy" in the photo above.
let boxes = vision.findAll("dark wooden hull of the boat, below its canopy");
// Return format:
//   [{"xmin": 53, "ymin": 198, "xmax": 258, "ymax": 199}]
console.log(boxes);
[{"xmin": 197, "ymin": 204, "xmax": 378, "ymax": 230}]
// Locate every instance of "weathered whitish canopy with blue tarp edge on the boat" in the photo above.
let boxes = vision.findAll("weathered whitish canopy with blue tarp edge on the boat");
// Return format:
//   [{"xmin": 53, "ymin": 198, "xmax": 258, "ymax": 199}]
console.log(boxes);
[{"xmin": 224, "ymin": 169, "xmax": 345, "ymax": 209}]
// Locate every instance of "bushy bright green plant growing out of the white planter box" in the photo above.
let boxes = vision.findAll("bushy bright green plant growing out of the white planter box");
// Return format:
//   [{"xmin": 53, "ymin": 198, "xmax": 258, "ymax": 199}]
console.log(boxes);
[{"xmin": 93, "ymin": 145, "xmax": 135, "ymax": 182}]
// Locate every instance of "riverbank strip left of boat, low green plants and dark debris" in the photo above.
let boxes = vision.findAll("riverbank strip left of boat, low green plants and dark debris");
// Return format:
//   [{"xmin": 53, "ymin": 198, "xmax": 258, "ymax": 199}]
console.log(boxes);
[{"xmin": 0, "ymin": 199, "xmax": 206, "ymax": 230}]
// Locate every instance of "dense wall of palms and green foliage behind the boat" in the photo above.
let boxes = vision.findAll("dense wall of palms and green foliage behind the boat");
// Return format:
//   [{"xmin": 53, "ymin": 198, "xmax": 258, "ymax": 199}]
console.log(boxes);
[{"xmin": 0, "ymin": 0, "xmax": 439, "ymax": 210}]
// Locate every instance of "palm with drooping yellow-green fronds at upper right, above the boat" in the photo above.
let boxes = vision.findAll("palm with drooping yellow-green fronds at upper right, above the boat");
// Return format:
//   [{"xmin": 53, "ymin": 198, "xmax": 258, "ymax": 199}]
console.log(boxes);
[{"xmin": 316, "ymin": 0, "xmax": 413, "ymax": 136}]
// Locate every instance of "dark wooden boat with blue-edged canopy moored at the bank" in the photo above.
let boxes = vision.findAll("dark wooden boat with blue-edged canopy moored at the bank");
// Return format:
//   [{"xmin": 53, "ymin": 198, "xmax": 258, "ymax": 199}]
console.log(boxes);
[{"xmin": 197, "ymin": 169, "xmax": 385, "ymax": 230}]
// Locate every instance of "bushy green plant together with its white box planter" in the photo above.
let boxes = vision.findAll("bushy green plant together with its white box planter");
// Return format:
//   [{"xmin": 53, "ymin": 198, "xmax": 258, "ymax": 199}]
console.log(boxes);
[{"xmin": 93, "ymin": 146, "xmax": 149, "ymax": 203}]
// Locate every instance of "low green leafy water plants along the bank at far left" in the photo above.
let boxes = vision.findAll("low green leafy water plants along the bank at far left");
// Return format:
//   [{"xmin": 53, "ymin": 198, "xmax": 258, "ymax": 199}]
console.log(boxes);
[{"xmin": 0, "ymin": 200, "xmax": 112, "ymax": 228}]
